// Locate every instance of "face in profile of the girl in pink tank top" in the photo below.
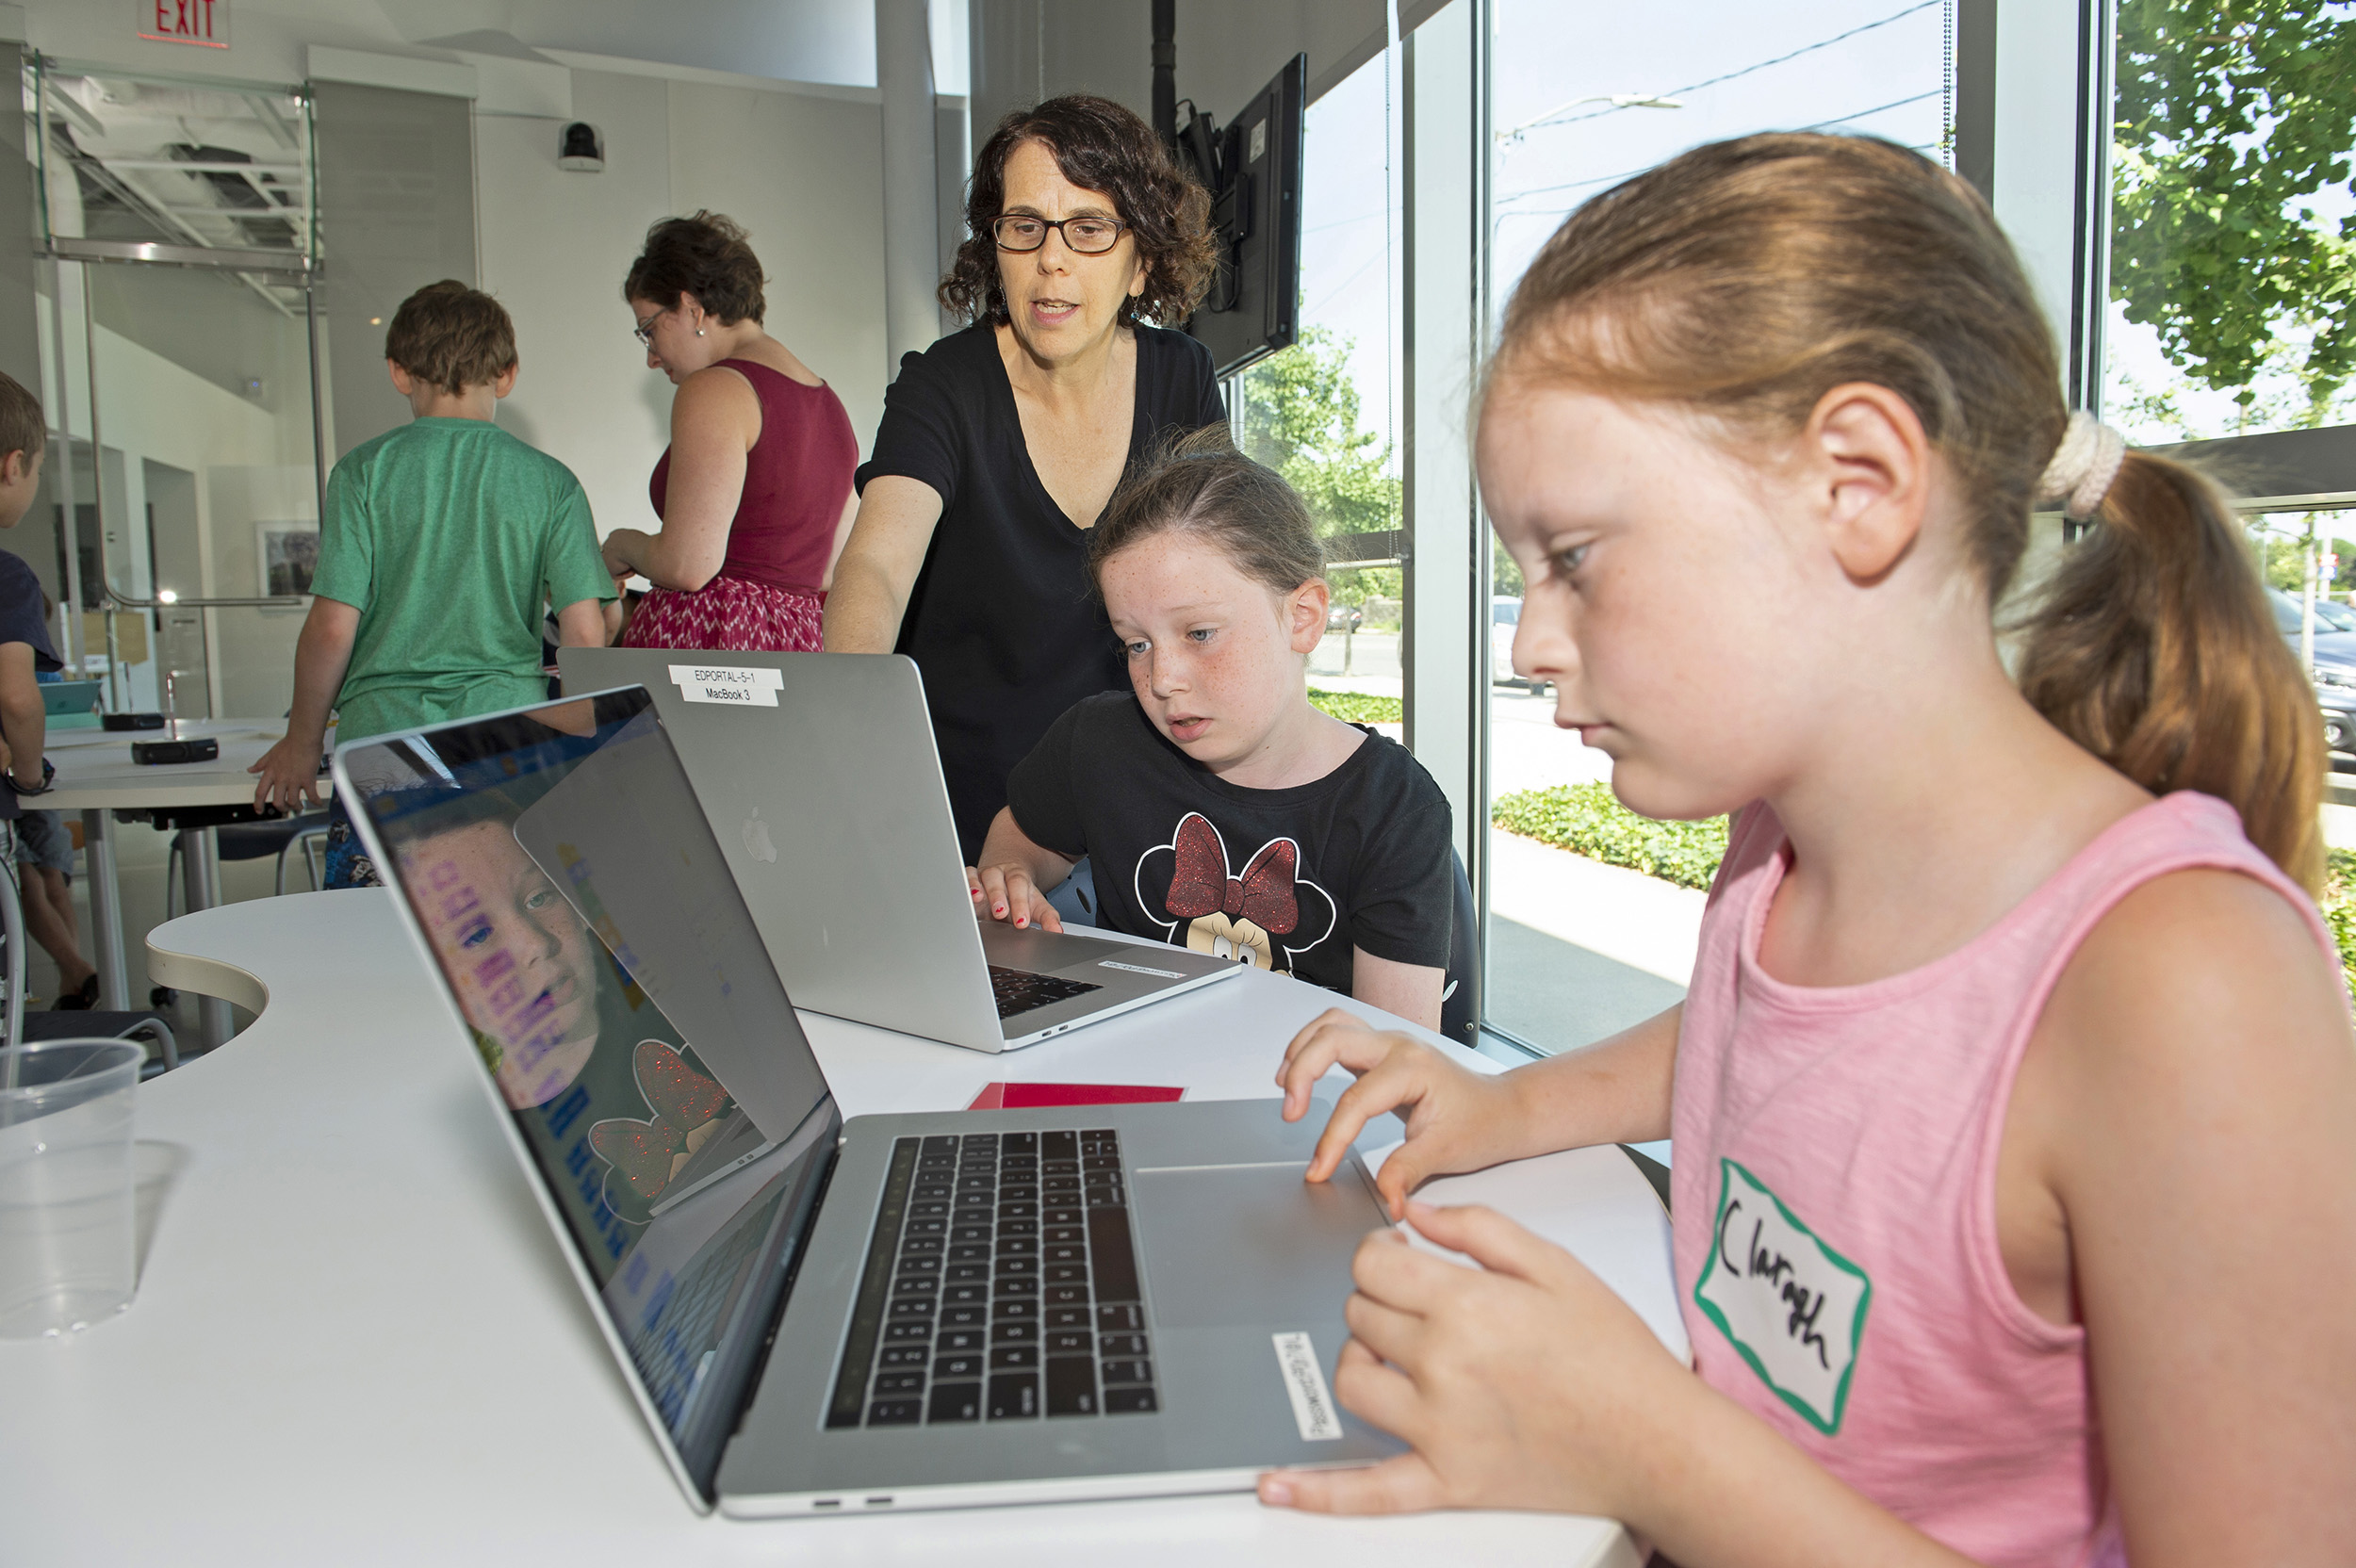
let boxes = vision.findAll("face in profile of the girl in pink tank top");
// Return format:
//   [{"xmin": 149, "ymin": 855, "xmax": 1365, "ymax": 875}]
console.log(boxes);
[{"xmin": 1478, "ymin": 377, "xmax": 1855, "ymax": 817}]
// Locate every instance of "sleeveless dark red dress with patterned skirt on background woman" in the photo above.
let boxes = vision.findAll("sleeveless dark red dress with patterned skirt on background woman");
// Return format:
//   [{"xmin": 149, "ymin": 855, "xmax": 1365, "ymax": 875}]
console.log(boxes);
[{"xmin": 622, "ymin": 360, "xmax": 860, "ymax": 652}]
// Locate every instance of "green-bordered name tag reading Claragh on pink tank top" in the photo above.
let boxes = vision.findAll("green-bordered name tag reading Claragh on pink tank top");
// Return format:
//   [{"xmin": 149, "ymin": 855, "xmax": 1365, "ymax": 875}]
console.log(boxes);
[{"xmin": 1694, "ymin": 1161, "xmax": 1873, "ymax": 1436}]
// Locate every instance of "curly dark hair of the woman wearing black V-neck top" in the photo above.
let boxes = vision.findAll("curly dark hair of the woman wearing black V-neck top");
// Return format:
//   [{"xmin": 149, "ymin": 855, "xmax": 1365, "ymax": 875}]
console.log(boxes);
[{"xmin": 941, "ymin": 91, "xmax": 1219, "ymax": 327}]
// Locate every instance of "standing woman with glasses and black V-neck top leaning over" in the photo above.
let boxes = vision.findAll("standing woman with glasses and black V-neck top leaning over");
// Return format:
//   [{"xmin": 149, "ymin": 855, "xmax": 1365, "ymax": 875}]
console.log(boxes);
[{"xmin": 827, "ymin": 94, "xmax": 1228, "ymax": 864}]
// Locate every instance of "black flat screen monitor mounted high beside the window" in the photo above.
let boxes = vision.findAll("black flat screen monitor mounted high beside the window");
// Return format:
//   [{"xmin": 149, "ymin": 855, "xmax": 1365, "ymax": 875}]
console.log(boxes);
[{"xmin": 1178, "ymin": 54, "xmax": 1310, "ymax": 377}]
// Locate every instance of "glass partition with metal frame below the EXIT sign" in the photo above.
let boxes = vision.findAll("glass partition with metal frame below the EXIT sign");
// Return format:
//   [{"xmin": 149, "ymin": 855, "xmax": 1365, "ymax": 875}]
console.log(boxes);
[{"xmin": 29, "ymin": 58, "xmax": 325, "ymax": 718}]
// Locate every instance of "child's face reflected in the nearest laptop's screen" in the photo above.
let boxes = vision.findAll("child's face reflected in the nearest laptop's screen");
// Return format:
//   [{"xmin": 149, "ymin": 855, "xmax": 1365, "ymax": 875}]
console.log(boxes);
[{"xmin": 403, "ymin": 822, "xmax": 597, "ymax": 1109}]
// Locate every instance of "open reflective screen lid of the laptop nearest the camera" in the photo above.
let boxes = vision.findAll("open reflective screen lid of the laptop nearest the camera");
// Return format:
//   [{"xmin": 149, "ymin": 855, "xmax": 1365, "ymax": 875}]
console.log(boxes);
[{"xmin": 335, "ymin": 690, "xmax": 839, "ymax": 1507}]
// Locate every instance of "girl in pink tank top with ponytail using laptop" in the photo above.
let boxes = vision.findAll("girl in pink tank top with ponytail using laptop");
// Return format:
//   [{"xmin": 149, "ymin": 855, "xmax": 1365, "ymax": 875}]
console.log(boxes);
[{"xmin": 1261, "ymin": 134, "xmax": 2356, "ymax": 1568}]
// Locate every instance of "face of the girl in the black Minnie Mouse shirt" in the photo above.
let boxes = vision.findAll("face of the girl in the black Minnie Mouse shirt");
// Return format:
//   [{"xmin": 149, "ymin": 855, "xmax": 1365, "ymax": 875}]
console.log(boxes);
[{"xmin": 1103, "ymin": 532, "xmax": 1324, "ymax": 770}]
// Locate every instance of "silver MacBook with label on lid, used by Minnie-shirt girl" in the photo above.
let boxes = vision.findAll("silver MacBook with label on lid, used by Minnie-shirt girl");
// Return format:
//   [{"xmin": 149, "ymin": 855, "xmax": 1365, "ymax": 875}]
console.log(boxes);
[{"xmin": 556, "ymin": 647, "xmax": 1239, "ymax": 1050}]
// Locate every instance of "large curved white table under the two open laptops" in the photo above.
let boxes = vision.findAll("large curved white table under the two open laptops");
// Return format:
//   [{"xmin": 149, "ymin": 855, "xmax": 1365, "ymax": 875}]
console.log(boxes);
[{"xmin": 0, "ymin": 892, "xmax": 1685, "ymax": 1568}]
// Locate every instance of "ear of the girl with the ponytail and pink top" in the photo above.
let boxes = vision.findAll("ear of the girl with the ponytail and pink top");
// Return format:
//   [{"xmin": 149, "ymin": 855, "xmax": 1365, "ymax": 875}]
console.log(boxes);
[{"xmin": 1800, "ymin": 382, "xmax": 1935, "ymax": 584}]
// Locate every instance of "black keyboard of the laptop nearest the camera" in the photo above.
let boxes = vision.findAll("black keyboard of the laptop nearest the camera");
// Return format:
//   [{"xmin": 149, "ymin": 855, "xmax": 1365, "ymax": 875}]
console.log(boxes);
[{"xmin": 827, "ymin": 1128, "xmax": 1159, "ymax": 1429}]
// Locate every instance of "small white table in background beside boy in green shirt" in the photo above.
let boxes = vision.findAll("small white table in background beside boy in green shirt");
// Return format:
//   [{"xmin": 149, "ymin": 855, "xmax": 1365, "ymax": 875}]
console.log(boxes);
[{"xmin": 31, "ymin": 718, "xmax": 328, "ymax": 1043}]
